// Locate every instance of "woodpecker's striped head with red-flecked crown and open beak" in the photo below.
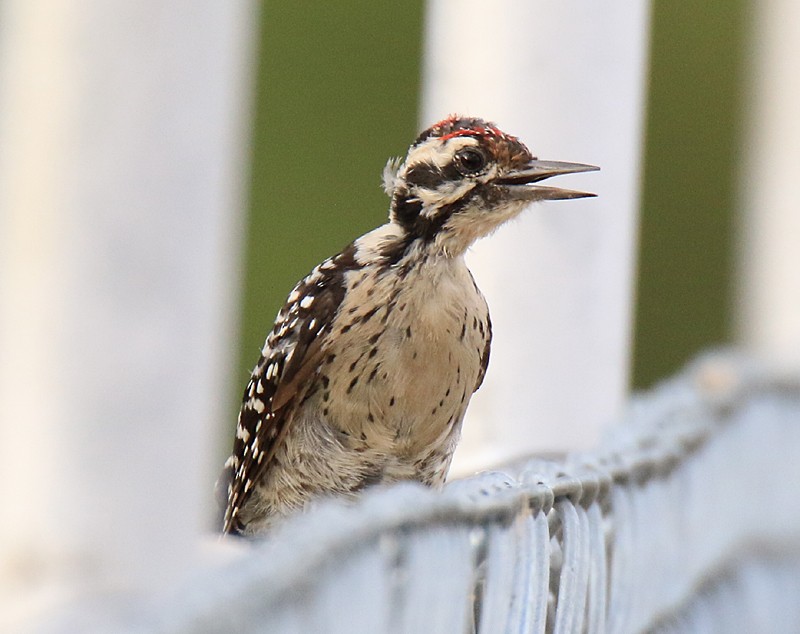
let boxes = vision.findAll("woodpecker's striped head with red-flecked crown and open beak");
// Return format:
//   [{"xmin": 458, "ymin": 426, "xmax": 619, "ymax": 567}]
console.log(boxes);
[{"xmin": 384, "ymin": 116, "xmax": 599, "ymax": 255}]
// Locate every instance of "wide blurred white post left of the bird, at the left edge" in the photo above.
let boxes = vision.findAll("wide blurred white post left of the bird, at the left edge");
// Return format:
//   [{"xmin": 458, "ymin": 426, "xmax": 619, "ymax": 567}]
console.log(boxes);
[{"xmin": 0, "ymin": 0, "xmax": 254, "ymax": 631}]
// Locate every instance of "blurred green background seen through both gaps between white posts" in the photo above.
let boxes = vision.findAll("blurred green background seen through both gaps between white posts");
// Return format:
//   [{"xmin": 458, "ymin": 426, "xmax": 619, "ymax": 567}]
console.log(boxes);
[{"xmin": 235, "ymin": 0, "xmax": 748, "ymax": 400}]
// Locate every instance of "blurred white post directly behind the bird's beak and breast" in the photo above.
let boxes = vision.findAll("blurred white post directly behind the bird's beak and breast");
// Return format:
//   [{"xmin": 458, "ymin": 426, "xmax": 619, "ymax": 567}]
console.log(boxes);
[{"xmin": 422, "ymin": 0, "xmax": 649, "ymax": 473}]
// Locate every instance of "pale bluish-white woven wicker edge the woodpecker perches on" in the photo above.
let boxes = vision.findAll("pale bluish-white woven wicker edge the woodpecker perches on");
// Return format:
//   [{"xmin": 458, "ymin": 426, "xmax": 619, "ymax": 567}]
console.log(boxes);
[{"xmin": 115, "ymin": 355, "xmax": 800, "ymax": 634}]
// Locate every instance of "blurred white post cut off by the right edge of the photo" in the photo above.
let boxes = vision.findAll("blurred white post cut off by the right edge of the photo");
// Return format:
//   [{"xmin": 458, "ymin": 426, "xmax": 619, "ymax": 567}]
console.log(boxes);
[{"xmin": 736, "ymin": 0, "xmax": 800, "ymax": 368}]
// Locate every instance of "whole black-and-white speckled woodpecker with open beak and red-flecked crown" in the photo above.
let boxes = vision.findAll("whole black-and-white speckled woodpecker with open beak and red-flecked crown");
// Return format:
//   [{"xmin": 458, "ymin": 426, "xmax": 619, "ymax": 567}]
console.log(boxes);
[{"xmin": 220, "ymin": 116, "xmax": 598, "ymax": 535}]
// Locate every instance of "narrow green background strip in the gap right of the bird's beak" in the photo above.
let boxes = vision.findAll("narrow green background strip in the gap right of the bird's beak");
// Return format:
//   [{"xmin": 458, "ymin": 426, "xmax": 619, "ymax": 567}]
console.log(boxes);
[{"xmin": 634, "ymin": 0, "xmax": 749, "ymax": 387}]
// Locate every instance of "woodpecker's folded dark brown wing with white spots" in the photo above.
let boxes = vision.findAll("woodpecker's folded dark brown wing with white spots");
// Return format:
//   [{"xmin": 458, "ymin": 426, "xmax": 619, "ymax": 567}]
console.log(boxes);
[{"xmin": 222, "ymin": 255, "xmax": 345, "ymax": 533}]
